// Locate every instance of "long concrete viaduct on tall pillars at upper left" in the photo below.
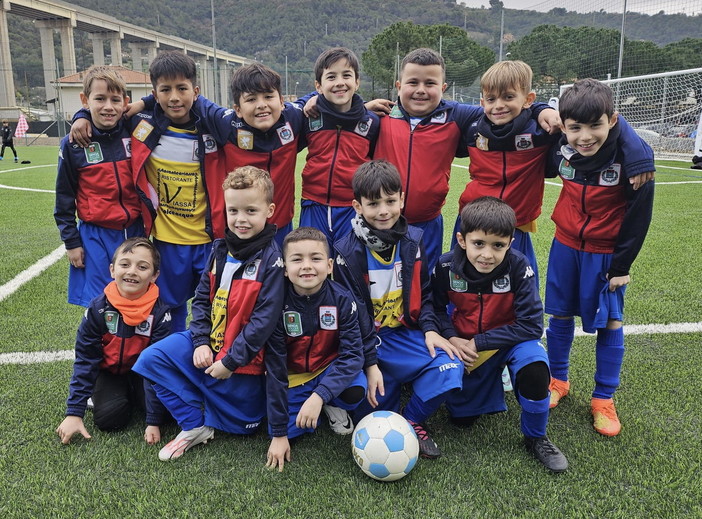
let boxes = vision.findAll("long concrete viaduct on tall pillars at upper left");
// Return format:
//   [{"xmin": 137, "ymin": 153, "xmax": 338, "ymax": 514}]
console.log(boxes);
[{"xmin": 0, "ymin": 0, "xmax": 252, "ymax": 106}]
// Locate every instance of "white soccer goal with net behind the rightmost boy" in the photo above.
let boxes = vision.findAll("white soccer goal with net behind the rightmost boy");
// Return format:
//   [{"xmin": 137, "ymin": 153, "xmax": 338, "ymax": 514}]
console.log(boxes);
[{"xmin": 560, "ymin": 68, "xmax": 702, "ymax": 160}]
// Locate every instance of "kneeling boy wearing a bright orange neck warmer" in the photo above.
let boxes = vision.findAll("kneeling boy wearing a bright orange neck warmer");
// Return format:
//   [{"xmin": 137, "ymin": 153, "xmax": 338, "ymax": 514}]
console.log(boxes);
[{"xmin": 56, "ymin": 237, "xmax": 171, "ymax": 445}]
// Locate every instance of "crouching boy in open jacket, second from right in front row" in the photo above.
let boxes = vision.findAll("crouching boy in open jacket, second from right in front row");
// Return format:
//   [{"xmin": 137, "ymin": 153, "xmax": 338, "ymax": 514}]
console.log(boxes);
[{"xmin": 334, "ymin": 160, "xmax": 463, "ymax": 458}]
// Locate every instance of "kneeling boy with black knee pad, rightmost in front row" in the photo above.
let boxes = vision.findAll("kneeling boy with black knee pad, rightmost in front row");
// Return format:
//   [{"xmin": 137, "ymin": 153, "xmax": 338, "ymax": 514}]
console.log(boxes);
[{"xmin": 432, "ymin": 197, "xmax": 568, "ymax": 472}]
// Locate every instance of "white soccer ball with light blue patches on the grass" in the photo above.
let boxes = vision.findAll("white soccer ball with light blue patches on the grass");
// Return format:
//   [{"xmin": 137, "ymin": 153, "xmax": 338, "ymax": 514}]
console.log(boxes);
[{"xmin": 351, "ymin": 411, "xmax": 419, "ymax": 481}]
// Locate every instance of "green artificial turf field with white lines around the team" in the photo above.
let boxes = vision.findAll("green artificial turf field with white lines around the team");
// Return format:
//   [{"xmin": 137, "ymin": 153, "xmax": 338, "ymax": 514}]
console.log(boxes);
[{"xmin": 0, "ymin": 146, "xmax": 702, "ymax": 519}]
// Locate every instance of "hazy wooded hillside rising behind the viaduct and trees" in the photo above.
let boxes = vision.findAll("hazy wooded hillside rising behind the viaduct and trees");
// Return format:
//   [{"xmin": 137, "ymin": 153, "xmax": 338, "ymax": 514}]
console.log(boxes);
[{"xmin": 8, "ymin": 0, "xmax": 702, "ymax": 101}]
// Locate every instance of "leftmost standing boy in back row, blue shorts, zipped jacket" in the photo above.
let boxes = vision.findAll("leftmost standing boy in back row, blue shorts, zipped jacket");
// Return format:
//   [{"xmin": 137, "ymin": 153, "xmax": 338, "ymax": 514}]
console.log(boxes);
[{"xmin": 54, "ymin": 66, "xmax": 144, "ymax": 306}]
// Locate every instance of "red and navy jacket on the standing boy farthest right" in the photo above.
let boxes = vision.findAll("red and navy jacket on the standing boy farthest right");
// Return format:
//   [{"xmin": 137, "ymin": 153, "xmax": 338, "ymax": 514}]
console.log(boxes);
[{"xmin": 548, "ymin": 122, "xmax": 655, "ymax": 277}]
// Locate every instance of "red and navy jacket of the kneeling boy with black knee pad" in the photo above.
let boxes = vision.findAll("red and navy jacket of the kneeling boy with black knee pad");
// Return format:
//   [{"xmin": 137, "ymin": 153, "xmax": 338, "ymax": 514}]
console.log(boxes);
[{"xmin": 432, "ymin": 249, "xmax": 543, "ymax": 351}]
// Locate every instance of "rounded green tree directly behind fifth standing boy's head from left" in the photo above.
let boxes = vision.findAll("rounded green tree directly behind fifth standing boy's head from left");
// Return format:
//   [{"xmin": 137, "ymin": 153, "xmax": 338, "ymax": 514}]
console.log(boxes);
[{"xmin": 362, "ymin": 22, "xmax": 495, "ymax": 96}]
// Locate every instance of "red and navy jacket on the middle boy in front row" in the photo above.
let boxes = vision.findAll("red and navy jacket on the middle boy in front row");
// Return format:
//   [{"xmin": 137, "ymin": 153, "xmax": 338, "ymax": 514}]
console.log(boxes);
[{"xmin": 268, "ymin": 280, "xmax": 368, "ymax": 430}]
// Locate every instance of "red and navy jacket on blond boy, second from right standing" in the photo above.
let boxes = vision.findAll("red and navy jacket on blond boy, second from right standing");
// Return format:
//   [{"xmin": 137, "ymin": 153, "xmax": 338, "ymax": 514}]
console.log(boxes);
[{"xmin": 458, "ymin": 107, "xmax": 558, "ymax": 226}]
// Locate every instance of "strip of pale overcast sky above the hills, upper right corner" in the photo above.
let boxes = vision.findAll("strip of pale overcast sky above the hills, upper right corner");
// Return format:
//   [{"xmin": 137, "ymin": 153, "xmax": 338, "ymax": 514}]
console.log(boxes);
[{"xmin": 459, "ymin": 0, "xmax": 702, "ymax": 15}]
